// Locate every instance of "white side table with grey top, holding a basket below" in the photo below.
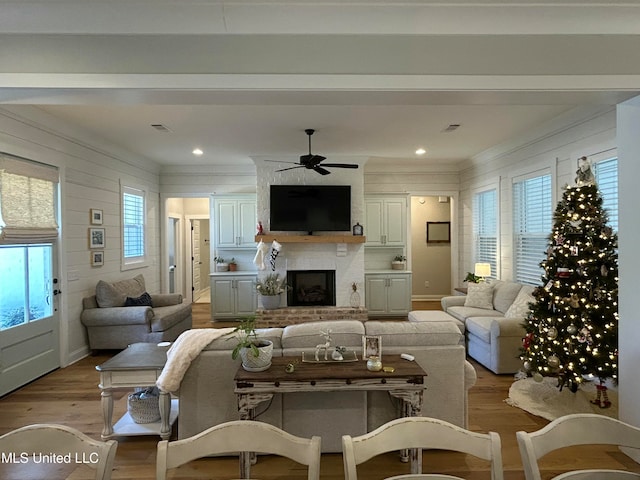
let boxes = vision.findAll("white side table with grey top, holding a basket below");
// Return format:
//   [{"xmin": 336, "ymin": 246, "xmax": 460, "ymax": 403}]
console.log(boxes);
[{"xmin": 96, "ymin": 343, "xmax": 179, "ymax": 440}]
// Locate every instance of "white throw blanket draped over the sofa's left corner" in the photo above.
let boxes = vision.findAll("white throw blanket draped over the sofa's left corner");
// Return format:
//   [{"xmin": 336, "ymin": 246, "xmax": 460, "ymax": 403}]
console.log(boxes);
[{"xmin": 156, "ymin": 327, "xmax": 234, "ymax": 392}]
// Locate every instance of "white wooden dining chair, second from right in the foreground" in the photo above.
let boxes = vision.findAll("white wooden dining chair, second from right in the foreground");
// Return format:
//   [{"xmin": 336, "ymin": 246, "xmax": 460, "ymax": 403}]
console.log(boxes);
[{"xmin": 342, "ymin": 417, "xmax": 503, "ymax": 480}]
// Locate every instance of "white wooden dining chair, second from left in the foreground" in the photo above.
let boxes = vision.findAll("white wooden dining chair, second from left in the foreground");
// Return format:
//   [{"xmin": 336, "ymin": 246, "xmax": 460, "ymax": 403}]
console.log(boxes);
[{"xmin": 156, "ymin": 420, "xmax": 321, "ymax": 480}]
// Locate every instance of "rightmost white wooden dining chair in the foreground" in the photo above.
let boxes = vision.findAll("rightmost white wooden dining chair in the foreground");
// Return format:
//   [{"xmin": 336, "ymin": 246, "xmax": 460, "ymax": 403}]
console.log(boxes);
[{"xmin": 516, "ymin": 413, "xmax": 640, "ymax": 480}]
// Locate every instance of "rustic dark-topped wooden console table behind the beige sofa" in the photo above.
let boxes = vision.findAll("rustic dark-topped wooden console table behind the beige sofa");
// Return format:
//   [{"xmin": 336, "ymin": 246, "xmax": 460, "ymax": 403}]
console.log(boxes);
[{"xmin": 234, "ymin": 355, "xmax": 427, "ymax": 478}]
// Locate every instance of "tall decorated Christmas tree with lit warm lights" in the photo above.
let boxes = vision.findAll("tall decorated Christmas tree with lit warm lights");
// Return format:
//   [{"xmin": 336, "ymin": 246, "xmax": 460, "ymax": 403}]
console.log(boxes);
[{"xmin": 521, "ymin": 157, "xmax": 618, "ymax": 408}]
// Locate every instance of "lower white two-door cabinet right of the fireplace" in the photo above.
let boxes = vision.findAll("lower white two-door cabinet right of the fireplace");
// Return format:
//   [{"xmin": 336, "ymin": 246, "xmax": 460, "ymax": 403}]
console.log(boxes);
[{"xmin": 364, "ymin": 272, "xmax": 411, "ymax": 317}]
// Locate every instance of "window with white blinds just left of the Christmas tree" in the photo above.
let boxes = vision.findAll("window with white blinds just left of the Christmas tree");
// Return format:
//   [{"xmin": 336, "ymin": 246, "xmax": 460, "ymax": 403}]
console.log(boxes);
[{"xmin": 513, "ymin": 174, "xmax": 553, "ymax": 285}]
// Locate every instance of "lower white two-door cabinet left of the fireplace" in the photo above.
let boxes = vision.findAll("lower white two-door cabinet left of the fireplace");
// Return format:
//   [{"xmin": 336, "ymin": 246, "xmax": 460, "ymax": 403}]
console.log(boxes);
[{"xmin": 211, "ymin": 274, "xmax": 258, "ymax": 320}]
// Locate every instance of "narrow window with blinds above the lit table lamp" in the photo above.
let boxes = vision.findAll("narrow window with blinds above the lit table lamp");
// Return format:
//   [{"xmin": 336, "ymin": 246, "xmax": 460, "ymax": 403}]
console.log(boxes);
[{"xmin": 473, "ymin": 188, "xmax": 498, "ymax": 278}]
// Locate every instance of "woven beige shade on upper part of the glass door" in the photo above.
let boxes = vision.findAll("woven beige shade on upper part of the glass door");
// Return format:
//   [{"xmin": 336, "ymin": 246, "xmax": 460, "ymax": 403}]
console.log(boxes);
[{"xmin": 0, "ymin": 153, "xmax": 58, "ymax": 244}]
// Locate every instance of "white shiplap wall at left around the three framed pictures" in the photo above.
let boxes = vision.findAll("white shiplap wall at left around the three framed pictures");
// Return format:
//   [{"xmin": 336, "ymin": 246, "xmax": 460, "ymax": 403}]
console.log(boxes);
[{"xmin": 0, "ymin": 106, "xmax": 160, "ymax": 366}]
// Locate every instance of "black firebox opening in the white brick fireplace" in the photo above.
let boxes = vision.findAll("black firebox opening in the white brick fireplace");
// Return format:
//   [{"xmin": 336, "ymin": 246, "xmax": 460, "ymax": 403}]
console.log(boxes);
[{"xmin": 287, "ymin": 270, "xmax": 336, "ymax": 307}]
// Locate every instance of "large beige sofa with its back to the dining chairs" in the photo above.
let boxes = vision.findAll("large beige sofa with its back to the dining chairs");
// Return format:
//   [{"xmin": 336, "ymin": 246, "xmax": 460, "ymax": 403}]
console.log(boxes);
[{"xmin": 178, "ymin": 320, "xmax": 476, "ymax": 452}]
